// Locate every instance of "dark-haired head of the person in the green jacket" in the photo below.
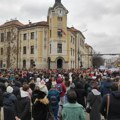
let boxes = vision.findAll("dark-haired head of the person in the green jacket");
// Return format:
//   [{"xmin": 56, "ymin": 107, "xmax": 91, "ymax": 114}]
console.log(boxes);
[{"xmin": 67, "ymin": 89, "xmax": 77, "ymax": 103}]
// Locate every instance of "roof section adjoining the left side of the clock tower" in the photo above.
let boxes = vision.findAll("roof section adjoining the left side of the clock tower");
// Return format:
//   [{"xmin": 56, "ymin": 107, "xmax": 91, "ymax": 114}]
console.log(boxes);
[{"xmin": 19, "ymin": 21, "xmax": 48, "ymax": 29}]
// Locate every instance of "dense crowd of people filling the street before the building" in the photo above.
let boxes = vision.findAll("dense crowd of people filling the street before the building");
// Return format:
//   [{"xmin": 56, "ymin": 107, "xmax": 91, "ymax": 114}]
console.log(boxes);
[{"xmin": 0, "ymin": 68, "xmax": 120, "ymax": 120}]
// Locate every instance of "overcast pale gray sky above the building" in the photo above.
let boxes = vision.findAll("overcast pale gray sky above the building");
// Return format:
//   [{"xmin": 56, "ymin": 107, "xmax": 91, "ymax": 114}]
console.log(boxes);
[{"xmin": 0, "ymin": 0, "xmax": 120, "ymax": 57}]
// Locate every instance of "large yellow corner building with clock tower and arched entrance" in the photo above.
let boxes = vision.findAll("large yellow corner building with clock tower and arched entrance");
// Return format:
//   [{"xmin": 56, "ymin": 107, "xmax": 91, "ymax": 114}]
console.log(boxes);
[{"xmin": 0, "ymin": 0, "xmax": 92, "ymax": 69}]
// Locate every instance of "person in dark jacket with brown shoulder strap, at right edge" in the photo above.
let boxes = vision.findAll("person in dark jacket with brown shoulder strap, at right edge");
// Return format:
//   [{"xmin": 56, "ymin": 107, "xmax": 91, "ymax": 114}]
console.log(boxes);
[{"xmin": 100, "ymin": 83, "xmax": 120, "ymax": 120}]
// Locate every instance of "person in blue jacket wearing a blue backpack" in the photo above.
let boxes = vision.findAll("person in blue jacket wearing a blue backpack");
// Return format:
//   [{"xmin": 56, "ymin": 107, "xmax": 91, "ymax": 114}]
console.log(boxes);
[{"xmin": 48, "ymin": 84, "xmax": 60, "ymax": 120}]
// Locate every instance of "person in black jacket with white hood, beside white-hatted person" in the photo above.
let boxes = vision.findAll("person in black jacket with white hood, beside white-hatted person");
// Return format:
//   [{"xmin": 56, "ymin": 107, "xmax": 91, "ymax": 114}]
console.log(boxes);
[{"xmin": 15, "ymin": 83, "xmax": 31, "ymax": 120}]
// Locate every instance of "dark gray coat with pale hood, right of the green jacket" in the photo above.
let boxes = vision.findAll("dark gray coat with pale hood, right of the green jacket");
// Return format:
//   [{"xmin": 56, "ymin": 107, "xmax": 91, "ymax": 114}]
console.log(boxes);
[{"xmin": 87, "ymin": 89, "xmax": 101, "ymax": 120}]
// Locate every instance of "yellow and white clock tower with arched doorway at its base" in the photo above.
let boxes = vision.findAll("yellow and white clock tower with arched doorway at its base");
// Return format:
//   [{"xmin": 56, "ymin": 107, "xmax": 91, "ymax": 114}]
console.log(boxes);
[{"xmin": 48, "ymin": 0, "xmax": 68, "ymax": 69}]
